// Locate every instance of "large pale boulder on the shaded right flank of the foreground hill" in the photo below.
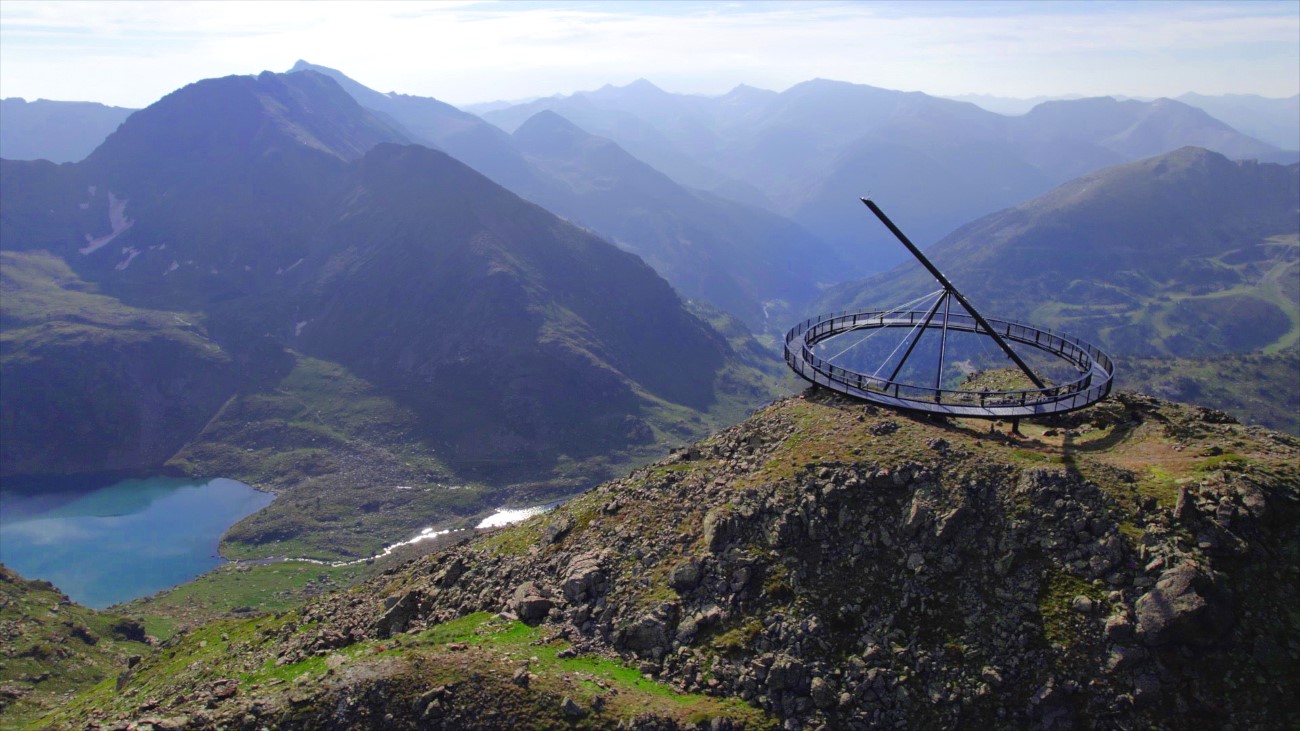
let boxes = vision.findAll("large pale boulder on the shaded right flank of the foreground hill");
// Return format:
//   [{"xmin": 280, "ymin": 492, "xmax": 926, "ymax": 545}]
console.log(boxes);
[{"xmin": 1135, "ymin": 562, "xmax": 1232, "ymax": 646}]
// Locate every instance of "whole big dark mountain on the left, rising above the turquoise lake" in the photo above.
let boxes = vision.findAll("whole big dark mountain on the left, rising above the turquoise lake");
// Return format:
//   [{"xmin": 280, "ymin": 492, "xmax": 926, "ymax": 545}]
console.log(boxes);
[{"xmin": 0, "ymin": 72, "xmax": 771, "ymax": 551}]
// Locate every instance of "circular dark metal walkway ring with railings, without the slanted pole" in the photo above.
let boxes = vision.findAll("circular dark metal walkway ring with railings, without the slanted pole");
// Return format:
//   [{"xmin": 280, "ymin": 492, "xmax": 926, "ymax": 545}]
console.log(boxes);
[{"xmin": 785, "ymin": 310, "xmax": 1114, "ymax": 419}]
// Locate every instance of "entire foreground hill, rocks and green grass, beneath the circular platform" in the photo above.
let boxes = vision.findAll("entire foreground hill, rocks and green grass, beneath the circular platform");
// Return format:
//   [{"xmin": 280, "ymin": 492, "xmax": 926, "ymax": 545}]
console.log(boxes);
[{"xmin": 46, "ymin": 390, "xmax": 1300, "ymax": 728}]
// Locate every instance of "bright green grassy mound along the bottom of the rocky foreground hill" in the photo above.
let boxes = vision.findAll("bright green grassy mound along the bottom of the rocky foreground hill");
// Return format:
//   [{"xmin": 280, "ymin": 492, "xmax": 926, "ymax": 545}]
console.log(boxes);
[{"xmin": 55, "ymin": 613, "xmax": 772, "ymax": 728}]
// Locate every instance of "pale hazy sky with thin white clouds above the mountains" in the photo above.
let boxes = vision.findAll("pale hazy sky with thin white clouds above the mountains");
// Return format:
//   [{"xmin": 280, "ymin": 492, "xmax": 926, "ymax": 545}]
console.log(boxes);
[{"xmin": 0, "ymin": 0, "xmax": 1300, "ymax": 107}]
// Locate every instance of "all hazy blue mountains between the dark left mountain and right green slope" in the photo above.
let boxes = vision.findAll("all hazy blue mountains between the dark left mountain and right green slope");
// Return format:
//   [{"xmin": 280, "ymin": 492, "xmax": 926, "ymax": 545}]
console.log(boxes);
[{"xmin": 7, "ymin": 74, "xmax": 1300, "ymax": 330}]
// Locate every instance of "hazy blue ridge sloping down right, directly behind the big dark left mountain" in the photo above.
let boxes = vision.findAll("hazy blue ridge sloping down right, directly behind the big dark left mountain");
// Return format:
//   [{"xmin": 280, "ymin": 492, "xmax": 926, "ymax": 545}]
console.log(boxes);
[{"xmin": 286, "ymin": 61, "xmax": 848, "ymax": 337}]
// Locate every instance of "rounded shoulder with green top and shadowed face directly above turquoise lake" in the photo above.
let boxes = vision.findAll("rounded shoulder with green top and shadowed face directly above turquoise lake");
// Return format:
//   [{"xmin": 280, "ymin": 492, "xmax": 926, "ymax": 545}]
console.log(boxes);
[{"xmin": 0, "ymin": 251, "xmax": 237, "ymax": 477}]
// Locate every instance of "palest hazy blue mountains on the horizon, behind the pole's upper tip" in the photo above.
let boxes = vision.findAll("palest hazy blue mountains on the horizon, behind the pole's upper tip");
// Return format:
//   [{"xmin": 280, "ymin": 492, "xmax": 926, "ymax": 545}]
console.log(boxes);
[{"xmin": 484, "ymin": 79, "xmax": 1295, "ymax": 271}]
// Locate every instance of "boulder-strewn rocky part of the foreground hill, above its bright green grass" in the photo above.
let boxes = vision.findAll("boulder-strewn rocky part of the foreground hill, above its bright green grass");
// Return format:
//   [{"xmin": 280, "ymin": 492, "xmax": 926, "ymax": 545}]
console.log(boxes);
[{"xmin": 65, "ymin": 395, "xmax": 1300, "ymax": 730}]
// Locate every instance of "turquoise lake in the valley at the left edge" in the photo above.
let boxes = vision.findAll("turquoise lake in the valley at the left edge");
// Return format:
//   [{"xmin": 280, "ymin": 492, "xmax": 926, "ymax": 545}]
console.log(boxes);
[{"xmin": 0, "ymin": 477, "xmax": 273, "ymax": 609}]
